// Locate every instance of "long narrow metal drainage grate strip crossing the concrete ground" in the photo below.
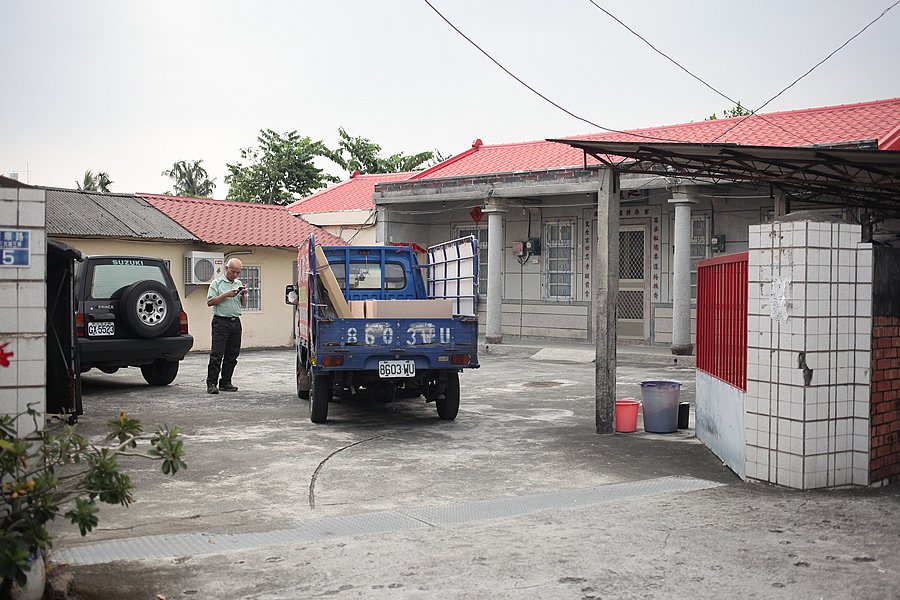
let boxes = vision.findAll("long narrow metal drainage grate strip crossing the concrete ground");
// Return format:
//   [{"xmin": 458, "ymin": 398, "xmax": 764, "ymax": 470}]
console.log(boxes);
[{"xmin": 53, "ymin": 477, "xmax": 724, "ymax": 565}]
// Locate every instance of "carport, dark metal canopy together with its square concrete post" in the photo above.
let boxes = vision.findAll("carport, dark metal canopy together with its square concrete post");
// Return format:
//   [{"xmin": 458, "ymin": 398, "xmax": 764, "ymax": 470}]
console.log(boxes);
[{"xmin": 549, "ymin": 139, "xmax": 900, "ymax": 440}]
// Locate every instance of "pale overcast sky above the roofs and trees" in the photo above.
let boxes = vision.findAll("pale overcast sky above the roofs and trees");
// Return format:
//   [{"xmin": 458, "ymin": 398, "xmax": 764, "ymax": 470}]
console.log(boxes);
[{"xmin": 0, "ymin": 0, "xmax": 900, "ymax": 198}]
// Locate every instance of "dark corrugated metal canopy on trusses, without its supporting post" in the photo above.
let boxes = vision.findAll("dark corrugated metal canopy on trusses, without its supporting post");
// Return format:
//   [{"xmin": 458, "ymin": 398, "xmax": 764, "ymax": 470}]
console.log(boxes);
[{"xmin": 548, "ymin": 139, "xmax": 900, "ymax": 213}]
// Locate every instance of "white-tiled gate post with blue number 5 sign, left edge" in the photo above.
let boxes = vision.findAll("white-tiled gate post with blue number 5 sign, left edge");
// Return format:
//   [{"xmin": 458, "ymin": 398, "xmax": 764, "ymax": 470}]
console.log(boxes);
[{"xmin": 0, "ymin": 188, "xmax": 47, "ymax": 436}]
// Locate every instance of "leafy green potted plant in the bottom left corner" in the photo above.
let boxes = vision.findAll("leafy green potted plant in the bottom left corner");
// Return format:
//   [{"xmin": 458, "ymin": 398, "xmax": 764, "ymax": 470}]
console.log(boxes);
[{"xmin": 0, "ymin": 406, "xmax": 187, "ymax": 599}]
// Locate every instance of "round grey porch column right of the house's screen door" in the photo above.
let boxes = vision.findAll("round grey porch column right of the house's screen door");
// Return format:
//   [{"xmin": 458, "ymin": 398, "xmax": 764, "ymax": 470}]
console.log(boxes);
[{"xmin": 669, "ymin": 192, "xmax": 697, "ymax": 355}]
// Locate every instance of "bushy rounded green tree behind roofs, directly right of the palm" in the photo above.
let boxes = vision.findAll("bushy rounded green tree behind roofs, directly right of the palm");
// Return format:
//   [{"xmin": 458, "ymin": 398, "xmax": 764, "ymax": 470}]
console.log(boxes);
[{"xmin": 225, "ymin": 129, "xmax": 340, "ymax": 205}]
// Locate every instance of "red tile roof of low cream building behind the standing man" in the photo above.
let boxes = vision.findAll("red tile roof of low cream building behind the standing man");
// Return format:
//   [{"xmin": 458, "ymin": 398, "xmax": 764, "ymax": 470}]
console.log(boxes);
[{"xmin": 137, "ymin": 194, "xmax": 347, "ymax": 248}]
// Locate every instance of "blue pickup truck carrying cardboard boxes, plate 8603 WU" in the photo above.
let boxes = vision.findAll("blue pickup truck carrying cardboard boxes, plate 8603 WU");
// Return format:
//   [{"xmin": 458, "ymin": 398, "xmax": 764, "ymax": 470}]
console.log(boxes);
[{"xmin": 285, "ymin": 236, "xmax": 479, "ymax": 423}]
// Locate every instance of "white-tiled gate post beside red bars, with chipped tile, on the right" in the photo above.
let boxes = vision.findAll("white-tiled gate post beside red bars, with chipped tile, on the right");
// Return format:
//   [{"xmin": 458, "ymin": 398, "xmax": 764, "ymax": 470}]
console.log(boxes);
[{"xmin": 746, "ymin": 221, "xmax": 872, "ymax": 489}]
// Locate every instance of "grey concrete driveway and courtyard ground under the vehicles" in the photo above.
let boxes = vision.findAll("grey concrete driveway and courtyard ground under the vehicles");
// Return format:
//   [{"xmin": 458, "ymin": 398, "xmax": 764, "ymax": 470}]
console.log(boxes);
[{"xmin": 51, "ymin": 350, "xmax": 900, "ymax": 599}]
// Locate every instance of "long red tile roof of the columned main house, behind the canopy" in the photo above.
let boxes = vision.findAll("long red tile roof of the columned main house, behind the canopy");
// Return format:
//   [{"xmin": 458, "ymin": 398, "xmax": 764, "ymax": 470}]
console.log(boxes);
[{"xmin": 410, "ymin": 98, "xmax": 900, "ymax": 179}]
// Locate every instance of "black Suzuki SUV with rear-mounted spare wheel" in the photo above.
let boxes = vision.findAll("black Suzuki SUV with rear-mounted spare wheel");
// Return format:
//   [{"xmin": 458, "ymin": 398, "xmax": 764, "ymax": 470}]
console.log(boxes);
[{"xmin": 75, "ymin": 256, "xmax": 194, "ymax": 385}]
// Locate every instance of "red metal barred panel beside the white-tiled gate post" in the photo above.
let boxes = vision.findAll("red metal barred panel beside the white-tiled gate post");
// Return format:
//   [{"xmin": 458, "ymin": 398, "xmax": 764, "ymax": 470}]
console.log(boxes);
[{"xmin": 697, "ymin": 252, "xmax": 748, "ymax": 391}]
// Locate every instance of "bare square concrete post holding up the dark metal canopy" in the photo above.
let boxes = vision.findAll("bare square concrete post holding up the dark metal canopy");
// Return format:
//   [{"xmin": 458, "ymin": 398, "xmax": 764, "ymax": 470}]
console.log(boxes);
[{"xmin": 594, "ymin": 169, "xmax": 619, "ymax": 433}]
